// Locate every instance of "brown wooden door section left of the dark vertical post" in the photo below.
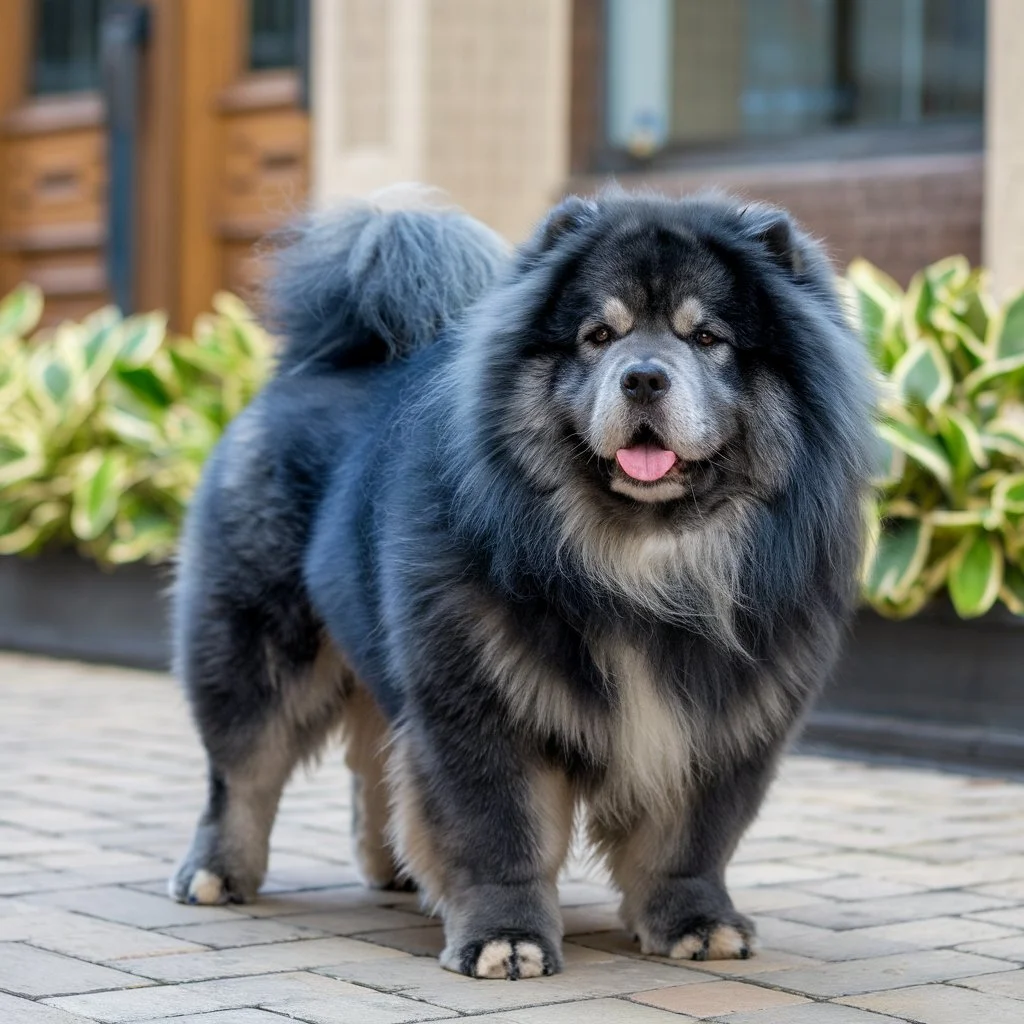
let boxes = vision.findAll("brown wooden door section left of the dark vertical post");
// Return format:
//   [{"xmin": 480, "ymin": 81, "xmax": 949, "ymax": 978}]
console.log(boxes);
[{"xmin": 0, "ymin": 0, "xmax": 106, "ymax": 321}]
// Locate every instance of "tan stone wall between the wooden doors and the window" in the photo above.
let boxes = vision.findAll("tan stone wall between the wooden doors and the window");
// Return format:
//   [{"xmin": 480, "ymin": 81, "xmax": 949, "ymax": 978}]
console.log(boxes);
[{"xmin": 312, "ymin": 0, "xmax": 570, "ymax": 240}]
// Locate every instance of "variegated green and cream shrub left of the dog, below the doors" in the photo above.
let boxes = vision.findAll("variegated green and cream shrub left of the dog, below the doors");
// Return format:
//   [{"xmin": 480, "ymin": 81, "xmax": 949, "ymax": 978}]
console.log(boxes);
[{"xmin": 0, "ymin": 285, "xmax": 271, "ymax": 564}]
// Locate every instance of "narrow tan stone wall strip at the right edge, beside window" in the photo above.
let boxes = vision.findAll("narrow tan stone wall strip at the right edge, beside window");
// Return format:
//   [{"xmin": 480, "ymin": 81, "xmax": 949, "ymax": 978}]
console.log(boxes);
[{"xmin": 984, "ymin": 0, "xmax": 1024, "ymax": 296}]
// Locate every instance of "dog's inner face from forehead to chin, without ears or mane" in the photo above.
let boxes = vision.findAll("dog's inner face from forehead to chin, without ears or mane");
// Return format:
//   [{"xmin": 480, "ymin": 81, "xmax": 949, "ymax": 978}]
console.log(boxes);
[{"xmin": 554, "ymin": 228, "xmax": 744, "ymax": 502}]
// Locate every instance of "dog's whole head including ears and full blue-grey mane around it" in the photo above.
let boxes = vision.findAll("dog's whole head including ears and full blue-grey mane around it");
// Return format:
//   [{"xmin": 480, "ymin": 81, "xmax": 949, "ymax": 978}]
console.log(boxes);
[{"xmin": 464, "ymin": 196, "xmax": 863, "ymax": 516}]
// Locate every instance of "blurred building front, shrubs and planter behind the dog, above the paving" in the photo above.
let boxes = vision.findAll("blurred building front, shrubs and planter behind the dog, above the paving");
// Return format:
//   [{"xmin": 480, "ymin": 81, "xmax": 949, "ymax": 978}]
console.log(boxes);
[{"xmin": 0, "ymin": 0, "xmax": 1024, "ymax": 769}]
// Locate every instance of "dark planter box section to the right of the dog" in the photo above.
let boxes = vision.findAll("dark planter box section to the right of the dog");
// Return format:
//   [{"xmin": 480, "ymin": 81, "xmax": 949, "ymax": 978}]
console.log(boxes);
[{"xmin": 802, "ymin": 602, "xmax": 1024, "ymax": 769}]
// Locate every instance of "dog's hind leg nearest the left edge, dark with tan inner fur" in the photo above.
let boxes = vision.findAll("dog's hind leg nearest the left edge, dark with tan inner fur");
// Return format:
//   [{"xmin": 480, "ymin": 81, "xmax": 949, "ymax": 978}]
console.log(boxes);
[{"xmin": 170, "ymin": 622, "xmax": 352, "ymax": 903}]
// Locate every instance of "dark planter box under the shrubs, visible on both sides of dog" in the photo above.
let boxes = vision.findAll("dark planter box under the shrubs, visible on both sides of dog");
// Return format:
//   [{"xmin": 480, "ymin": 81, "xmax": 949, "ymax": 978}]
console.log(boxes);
[{"xmin": 0, "ymin": 551, "xmax": 1024, "ymax": 770}]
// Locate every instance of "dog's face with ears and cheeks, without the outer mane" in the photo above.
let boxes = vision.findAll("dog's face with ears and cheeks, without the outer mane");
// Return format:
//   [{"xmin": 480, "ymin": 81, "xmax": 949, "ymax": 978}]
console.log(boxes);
[{"xmin": 495, "ymin": 195, "xmax": 815, "ymax": 515}]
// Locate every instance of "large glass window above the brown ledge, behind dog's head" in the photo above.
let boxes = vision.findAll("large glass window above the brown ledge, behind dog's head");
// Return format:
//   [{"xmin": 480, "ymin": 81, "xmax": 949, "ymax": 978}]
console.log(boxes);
[{"xmin": 608, "ymin": 0, "xmax": 985, "ymax": 155}]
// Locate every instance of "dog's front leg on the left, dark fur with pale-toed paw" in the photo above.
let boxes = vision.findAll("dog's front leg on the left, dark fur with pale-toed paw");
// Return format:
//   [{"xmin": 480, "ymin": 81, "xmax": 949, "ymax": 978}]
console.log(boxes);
[{"xmin": 391, "ymin": 700, "xmax": 572, "ymax": 979}]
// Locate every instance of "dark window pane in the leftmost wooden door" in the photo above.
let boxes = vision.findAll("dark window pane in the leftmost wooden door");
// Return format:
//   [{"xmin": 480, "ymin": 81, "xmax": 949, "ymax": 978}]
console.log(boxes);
[{"xmin": 32, "ymin": 0, "xmax": 104, "ymax": 93}]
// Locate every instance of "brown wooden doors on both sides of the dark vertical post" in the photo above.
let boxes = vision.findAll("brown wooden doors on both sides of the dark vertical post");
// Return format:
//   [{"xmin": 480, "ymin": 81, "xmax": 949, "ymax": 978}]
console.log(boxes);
[{"xmin": 0, "ymin": 0, "xmax": 309, "ymax": 329}]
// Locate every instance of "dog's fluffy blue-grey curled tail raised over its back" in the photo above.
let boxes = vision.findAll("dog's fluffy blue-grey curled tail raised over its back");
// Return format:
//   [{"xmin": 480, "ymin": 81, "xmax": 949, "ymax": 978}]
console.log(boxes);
[{"xmin": 266, "ymin": 186, "xmax": 509, "ymax": 374}]
